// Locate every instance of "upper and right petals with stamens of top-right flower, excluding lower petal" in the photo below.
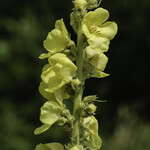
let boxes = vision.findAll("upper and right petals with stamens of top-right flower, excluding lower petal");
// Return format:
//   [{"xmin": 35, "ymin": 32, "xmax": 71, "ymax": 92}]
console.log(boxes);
[{"xmin": 82, "ymin": 8, "xmax": 117, "ymax": 40}]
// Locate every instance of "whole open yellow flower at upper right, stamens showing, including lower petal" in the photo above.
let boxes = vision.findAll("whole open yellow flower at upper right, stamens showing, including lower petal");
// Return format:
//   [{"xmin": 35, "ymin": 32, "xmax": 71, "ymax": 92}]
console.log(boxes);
[{"xmin": 82, "ymin": 8, "xmax": 117, "ymax": 57}]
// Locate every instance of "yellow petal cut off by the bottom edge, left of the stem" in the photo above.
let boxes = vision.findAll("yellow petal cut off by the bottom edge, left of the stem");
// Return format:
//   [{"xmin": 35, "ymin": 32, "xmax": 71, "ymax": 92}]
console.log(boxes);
[{"xmin": 35, "ymin": 143, "xmax": 64, "ymax": 150}]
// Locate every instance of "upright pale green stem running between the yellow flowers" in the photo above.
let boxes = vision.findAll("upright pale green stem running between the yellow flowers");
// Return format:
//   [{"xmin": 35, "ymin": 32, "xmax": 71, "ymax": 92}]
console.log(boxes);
[{"xmin": 72, "ymin": 23, "xmax": 83, "ymax": 146}]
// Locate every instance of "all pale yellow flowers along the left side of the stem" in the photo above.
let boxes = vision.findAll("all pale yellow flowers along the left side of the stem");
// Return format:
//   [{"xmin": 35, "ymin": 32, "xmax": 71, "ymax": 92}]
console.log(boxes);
[{"xmin": 34, "ymin": 19, "xmax": 77, "ymax": 150}]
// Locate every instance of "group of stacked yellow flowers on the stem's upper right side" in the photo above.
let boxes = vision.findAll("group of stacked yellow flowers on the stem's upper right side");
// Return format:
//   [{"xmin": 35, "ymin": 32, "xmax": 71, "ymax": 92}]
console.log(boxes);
[{"xmin": 82, "ymin": 8, "xmax": 117, "ymax": 78}]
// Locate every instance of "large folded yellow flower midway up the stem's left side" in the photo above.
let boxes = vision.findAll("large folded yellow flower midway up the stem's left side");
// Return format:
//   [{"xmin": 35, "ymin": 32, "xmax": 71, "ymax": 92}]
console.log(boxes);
[{"xmin": 41, "ymin": 53, "xmax": 77, "ymax": 93}]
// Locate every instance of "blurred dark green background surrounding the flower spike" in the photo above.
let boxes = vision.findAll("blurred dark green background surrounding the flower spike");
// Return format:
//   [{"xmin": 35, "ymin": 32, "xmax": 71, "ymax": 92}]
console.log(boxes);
[{"xmin": 0, "ymin": 0, "xmax": 150, "ymax": 150}]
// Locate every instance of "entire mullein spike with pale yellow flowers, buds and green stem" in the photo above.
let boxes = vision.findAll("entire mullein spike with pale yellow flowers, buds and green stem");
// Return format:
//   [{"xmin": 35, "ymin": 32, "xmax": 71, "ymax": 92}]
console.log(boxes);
[{"xmin": 34, "ymin": 0, "xmax": 117, "ymax": 150}]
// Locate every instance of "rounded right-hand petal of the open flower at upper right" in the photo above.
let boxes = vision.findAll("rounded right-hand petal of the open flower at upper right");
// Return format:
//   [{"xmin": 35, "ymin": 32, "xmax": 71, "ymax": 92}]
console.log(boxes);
[{"xmin": 99, "ymin": 21, "xmax": 118, "ymax": 40}]
